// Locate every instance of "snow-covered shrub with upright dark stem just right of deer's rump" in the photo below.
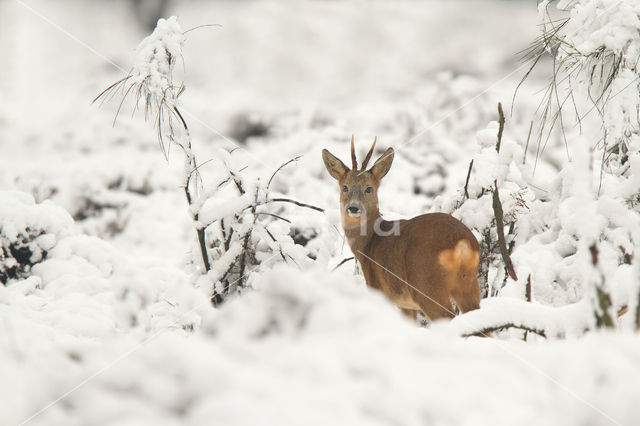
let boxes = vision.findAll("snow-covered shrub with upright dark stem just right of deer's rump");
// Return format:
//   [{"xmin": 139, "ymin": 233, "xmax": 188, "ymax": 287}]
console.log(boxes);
[{"xmin": 436, "ymin": 104, "xmax": 640, "ymax": 337}]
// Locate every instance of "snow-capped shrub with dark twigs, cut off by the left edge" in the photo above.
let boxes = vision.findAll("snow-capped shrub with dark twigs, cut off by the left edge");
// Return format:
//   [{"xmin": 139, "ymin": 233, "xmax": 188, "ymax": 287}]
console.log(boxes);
[{"xmin": 0, "ymin": 192, "xmax": 73, "ymax": 285}]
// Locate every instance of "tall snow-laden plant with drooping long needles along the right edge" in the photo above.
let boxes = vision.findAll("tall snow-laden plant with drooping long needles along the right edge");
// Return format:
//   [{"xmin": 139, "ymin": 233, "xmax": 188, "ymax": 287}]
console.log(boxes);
[{"xmin": 532, "ymin": 0, "xmax": 640, "ymax": 325}]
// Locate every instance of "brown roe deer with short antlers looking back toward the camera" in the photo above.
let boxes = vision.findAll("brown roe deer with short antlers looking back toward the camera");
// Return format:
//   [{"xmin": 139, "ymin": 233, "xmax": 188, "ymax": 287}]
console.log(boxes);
[{"xmin": 322, "ymin": 136, "xmax": 480, "ymax": 320}]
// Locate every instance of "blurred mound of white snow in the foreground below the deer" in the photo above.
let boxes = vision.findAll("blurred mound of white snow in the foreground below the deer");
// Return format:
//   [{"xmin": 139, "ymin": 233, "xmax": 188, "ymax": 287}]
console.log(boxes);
[{"xmin": 2, "ymin": 267, "xmax": 640, "ymax": 424}]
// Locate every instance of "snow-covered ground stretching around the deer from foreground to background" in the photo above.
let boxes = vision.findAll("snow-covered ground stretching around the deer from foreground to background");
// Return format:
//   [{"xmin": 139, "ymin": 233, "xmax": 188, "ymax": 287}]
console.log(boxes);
[{"xmin": 0, "ymin": 0, "xmax": 640, "ymax": 425}]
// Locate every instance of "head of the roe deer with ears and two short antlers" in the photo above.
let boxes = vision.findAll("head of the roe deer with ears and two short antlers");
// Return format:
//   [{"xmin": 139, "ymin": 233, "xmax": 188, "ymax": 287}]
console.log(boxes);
[{"xmin": 322, "ymin": 136, "xmax": 393, "ymax": 230}]
